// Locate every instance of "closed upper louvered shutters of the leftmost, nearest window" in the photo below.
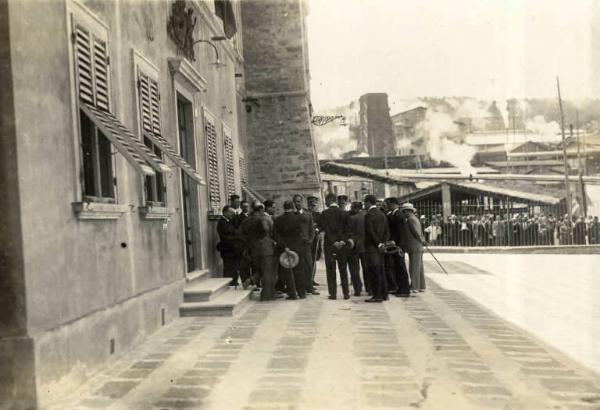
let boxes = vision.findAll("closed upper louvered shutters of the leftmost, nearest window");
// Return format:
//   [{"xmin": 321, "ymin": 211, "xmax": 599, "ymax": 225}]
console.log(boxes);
[{"xmin": 73, "ymin": 24, "xmax": 110, "ymax": 111}]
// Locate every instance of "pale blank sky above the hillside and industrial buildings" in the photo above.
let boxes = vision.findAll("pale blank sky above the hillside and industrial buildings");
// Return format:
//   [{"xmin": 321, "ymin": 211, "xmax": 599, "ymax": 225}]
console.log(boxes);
[{"xmin": 307, "ymin": 0, "xmax": 600, "ymax": 112}]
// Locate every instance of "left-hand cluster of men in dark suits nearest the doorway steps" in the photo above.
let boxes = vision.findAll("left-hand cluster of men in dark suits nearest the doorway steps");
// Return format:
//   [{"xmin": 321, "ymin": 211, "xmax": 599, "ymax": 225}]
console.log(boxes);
[{"xmin": 217, "ymin": 194, "xmax": 319, "ymax": 300}]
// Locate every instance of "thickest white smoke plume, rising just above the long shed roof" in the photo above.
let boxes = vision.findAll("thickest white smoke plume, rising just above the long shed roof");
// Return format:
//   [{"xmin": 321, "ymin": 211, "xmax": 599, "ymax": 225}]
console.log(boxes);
[{"xmin": 417, "ymin": 110, "xmax": 476, "ymax": 175}]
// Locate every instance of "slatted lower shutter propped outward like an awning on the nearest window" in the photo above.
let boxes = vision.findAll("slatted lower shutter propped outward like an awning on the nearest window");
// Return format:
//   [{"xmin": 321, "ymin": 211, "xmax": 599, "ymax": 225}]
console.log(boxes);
[{"xmin": 79, "ymin": 101, "xmax": 171, "ymax": 175}]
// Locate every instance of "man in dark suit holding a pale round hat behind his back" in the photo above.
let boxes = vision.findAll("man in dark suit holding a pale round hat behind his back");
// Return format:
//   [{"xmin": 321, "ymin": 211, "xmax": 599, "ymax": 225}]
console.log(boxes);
[{"xmin": 273, "ymin": 201, "xmax": 310, "ymax": 299}]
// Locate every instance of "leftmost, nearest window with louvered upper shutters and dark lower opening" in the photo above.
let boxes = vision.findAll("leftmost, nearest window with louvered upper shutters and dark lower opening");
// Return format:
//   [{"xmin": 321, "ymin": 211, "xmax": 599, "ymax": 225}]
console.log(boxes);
[{"xmin": 73, "ymin": 24, "xmax": 116, "ymax": 202}]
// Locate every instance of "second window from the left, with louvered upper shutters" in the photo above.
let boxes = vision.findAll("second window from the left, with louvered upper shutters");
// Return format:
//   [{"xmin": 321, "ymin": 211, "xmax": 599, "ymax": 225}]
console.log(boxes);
[{"xmin": 137, "ymin": 68, "xmax": 167, "ymax": 206}]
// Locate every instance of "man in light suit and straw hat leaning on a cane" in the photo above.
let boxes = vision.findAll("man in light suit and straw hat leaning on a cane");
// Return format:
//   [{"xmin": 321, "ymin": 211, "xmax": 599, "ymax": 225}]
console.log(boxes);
[{"xmin": 400, "ymin": 202, "xmax": 427, "ymax": 292}]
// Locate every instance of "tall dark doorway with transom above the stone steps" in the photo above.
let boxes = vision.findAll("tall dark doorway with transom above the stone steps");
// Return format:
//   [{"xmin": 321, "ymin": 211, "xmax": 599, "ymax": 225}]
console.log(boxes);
[{"xmin": 177, "ymin": 93, "xmax": 202, "ymax": 275}]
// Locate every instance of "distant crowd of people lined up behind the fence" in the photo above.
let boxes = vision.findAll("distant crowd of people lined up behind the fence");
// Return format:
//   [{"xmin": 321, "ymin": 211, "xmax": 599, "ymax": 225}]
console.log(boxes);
[{"xmin": 420, "ymin": 213, "xmax": 600, "ymax": 246}]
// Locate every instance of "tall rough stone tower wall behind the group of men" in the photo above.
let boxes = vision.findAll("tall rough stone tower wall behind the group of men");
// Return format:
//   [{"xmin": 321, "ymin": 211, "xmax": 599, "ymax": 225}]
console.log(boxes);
[{"xmin": 242, "ymin": 0, "xmax": 320, "ymax": 202}]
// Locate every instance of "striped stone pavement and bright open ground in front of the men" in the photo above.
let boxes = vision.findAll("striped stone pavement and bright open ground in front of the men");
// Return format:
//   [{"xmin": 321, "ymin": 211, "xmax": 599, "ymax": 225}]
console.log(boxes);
[{"xmin": 48, "ymin": 255, "xmax": 600, "ymax": 410}]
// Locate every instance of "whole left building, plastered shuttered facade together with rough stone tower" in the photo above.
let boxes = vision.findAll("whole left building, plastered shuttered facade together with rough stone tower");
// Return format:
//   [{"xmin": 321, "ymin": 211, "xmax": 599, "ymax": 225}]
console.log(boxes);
[{"xmin": 0, "ymin": 0, "xmax": 310, "ymax": 409}]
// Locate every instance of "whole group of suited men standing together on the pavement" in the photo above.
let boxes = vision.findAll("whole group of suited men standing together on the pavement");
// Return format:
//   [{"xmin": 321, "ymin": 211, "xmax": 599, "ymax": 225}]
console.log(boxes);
[{"xmin": 217, "ymin": 194, "xmax": 427, "ymax": 303}]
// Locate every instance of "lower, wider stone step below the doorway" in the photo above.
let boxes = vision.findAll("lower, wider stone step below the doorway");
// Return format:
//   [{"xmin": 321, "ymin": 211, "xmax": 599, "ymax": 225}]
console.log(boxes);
[{"xmin": 179, "ymin": 287, "xmax": 252, "ymax": 316}]
